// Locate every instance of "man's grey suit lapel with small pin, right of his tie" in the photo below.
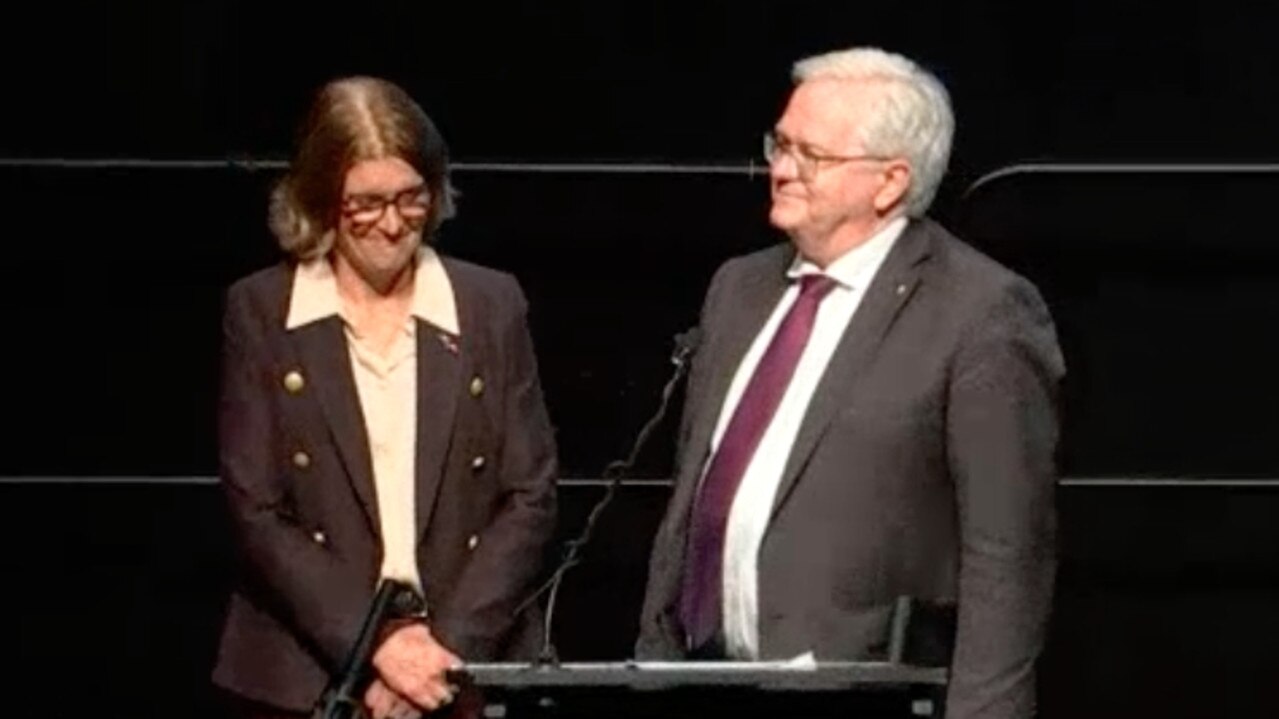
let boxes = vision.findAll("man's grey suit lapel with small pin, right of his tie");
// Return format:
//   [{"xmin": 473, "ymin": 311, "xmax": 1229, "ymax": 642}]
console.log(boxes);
[{"xmin": 773, "ymin": 221, "xmax": 929, "ymax": 516}]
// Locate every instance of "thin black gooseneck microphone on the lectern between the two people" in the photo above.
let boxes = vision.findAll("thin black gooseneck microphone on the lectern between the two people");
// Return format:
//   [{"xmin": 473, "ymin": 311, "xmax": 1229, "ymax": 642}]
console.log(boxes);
[{"xmin": 515, "ymin": 326, "xmax": 701, "ymax": 664}]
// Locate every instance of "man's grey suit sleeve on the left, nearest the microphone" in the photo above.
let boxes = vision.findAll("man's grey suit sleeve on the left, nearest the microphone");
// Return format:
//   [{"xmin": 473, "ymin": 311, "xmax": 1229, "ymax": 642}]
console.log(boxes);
[{"xmin": 634, "ymin": 255, "xmax": 732, "ymax": 660}]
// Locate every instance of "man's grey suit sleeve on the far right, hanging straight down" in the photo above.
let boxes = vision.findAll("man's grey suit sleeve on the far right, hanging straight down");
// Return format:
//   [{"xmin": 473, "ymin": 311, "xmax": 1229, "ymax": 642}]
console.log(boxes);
[{"xmin": 946, "ymin": 275, "xmax": 1064, "ymax": 719}]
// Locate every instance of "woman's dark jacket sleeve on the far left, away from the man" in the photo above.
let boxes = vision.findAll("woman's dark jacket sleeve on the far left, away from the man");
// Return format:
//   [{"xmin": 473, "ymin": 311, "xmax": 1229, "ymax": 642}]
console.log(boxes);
[{"xmin": 219, "ymin": 289, "xmax": 372, "ymax": 670}]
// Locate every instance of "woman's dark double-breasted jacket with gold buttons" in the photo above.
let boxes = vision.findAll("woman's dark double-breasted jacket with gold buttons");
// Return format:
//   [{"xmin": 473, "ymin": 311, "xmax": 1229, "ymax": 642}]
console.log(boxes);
[{"xmin": 214, "ymin": 258, "xmax": 556, "ymax": 710}]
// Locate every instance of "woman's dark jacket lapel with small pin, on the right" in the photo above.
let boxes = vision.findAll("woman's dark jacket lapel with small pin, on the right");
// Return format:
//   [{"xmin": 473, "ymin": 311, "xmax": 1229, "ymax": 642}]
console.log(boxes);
[{"xmin": 413, "ymin": 320, "xmax": 468, "ymax": 537}]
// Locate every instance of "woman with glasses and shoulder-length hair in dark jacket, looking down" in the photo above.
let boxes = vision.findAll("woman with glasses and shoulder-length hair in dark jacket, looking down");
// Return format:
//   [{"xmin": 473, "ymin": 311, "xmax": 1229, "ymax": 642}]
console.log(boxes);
[{"xmin": 214, "ymin": 78, "xmax": 556, "ymax": 716}]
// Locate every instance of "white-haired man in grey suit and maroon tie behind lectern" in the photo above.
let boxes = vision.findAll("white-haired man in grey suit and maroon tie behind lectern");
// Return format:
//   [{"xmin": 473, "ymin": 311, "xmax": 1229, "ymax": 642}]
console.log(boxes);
[{"xmin": 637, "ymin": 49, "xmax": 1064, "ymax": 718}]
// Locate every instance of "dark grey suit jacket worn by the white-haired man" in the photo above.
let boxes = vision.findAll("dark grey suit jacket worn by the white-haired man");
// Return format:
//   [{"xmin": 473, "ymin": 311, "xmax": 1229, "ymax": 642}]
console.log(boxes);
[{"xmin": 636, "ymin": 220, "xmax": 1064, "ymax": 718}]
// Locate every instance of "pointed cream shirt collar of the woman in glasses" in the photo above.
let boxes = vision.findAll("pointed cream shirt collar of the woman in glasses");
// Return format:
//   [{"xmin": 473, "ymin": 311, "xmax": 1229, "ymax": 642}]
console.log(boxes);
[{"xmin": 284, "ymin": 247, "xmax": 462, "ymax": 335}]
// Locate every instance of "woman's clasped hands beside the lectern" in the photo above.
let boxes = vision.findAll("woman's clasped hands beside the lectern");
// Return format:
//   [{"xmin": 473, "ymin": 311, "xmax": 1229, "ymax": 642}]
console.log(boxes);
[{"xmin": 366, "ymin": 623, "xmax": 462, "ymax": 711}]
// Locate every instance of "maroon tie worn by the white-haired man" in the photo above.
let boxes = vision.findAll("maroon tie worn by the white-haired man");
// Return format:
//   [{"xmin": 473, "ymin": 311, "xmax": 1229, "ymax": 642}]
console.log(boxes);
[{"xmin": 679, "ymin": 275, "xmax": 835, "ymax": 649}]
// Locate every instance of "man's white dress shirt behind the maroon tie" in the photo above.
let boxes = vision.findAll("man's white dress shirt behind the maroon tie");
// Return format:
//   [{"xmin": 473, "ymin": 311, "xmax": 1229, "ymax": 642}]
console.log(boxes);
[{"xmin": 702, "ymin": 217, "xmax": 907, "ymax": 660}]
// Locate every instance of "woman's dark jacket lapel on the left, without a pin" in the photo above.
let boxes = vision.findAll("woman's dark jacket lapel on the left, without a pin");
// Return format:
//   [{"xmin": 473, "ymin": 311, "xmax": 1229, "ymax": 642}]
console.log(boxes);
[{"xmin": 292, "ymin": 316, "xmax": 381, "ymax": 536}]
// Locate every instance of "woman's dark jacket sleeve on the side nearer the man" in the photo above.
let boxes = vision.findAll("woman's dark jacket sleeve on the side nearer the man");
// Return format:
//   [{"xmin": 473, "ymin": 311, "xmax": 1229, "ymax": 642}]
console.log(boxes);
[{"xmin": 437, "ymin": 281, "xmax": 558, "ymax": 660}]
